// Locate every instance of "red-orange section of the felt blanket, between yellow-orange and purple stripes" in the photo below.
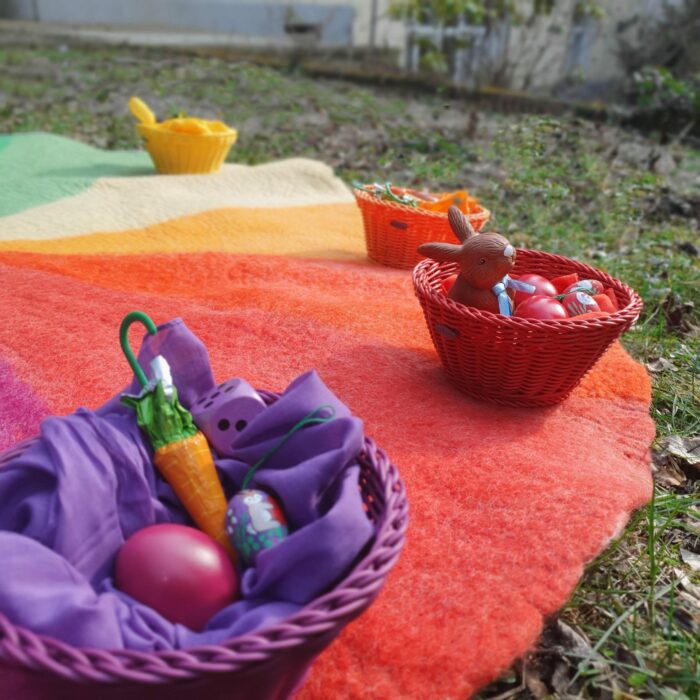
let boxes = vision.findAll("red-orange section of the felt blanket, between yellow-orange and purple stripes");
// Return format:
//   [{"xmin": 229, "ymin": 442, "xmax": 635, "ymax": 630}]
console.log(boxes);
[{"xmin": 0, "ymin": 249, "xmax": 654, "ymax": 700}]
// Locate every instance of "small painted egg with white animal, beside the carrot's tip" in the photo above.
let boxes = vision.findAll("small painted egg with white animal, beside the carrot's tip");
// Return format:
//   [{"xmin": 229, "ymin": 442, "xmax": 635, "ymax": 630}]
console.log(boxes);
[{"xmin": 226, "ymin": 489, "xmax": 289, "ymax": 566}]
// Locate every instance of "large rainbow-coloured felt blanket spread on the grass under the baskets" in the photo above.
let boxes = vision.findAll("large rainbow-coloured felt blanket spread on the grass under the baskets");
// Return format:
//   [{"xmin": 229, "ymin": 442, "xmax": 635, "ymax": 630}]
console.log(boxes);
[{"xmin": 0, "ymin": 134, "xmax": 654, "ymax": 700}]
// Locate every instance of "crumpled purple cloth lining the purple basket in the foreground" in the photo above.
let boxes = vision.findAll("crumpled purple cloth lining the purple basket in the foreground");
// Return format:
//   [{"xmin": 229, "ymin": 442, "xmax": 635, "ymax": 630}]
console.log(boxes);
[{"xmin": 0, "ymin": 319, "xmax": 373, "ymax": 651}]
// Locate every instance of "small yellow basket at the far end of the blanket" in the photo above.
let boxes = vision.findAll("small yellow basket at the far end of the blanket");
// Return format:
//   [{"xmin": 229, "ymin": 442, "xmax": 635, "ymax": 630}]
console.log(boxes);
[{"xmin": 136, "ymin": 124, "xmax": 238, "ymax": 175}]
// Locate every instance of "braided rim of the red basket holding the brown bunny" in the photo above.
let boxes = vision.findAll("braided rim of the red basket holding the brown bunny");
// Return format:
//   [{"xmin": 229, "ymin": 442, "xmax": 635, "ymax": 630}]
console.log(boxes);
[{"xmin": 413, "ymin": 248, "xmax": 644, "ymax": 332}]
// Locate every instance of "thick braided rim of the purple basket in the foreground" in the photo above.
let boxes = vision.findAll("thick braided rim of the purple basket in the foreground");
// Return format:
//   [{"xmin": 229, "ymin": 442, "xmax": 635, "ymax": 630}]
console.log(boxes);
[{"xmin": 0, "ymin": 390, "xmax": 408, "ymax": 684}]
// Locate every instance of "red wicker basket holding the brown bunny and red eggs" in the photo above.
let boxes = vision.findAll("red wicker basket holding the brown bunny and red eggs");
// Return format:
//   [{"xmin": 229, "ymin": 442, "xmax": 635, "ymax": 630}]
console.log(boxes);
[{"xmin": 413, "ymin": 249, "xmax": 642, "ymax": 406}]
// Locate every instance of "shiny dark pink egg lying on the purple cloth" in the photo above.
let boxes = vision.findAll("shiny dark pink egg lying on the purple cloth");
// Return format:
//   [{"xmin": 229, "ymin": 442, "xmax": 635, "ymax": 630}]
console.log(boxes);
[{"xmin": 115, "ymin": 524, "xmax": 238, "ymax": 631}]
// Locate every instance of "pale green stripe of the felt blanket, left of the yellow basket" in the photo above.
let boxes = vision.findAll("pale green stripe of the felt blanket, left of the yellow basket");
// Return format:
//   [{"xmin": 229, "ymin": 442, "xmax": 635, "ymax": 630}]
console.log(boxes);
[{"xmin": 0, "ymin": 133, "xmax": 155, "ymax": 217}]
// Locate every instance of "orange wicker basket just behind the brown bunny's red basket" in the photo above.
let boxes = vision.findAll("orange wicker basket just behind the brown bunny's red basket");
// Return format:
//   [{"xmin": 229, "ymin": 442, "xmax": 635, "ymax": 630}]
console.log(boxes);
[{"xmin": 355, "ymin": 189, "xmax": 491, "ymax": 270}]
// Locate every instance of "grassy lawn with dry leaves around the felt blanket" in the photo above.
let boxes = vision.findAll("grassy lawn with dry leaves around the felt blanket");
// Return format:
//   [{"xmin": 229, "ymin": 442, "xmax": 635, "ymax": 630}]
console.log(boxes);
[{"xmin": 0, "ymin": 37, "xmax": 700, "ymax": 700}]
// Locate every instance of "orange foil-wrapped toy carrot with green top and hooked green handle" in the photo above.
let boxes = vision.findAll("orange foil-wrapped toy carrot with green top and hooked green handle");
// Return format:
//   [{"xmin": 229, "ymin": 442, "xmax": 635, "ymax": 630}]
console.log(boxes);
[{"xmin": 119, "ymin": 311, "xmax": 235, "ymax": 558}]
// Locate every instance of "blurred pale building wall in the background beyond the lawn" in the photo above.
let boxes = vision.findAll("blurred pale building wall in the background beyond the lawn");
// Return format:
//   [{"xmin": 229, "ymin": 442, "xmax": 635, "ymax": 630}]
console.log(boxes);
[{"xmin": 0, "ymin": 0, "xmax": 682, "ymax": 93}]
